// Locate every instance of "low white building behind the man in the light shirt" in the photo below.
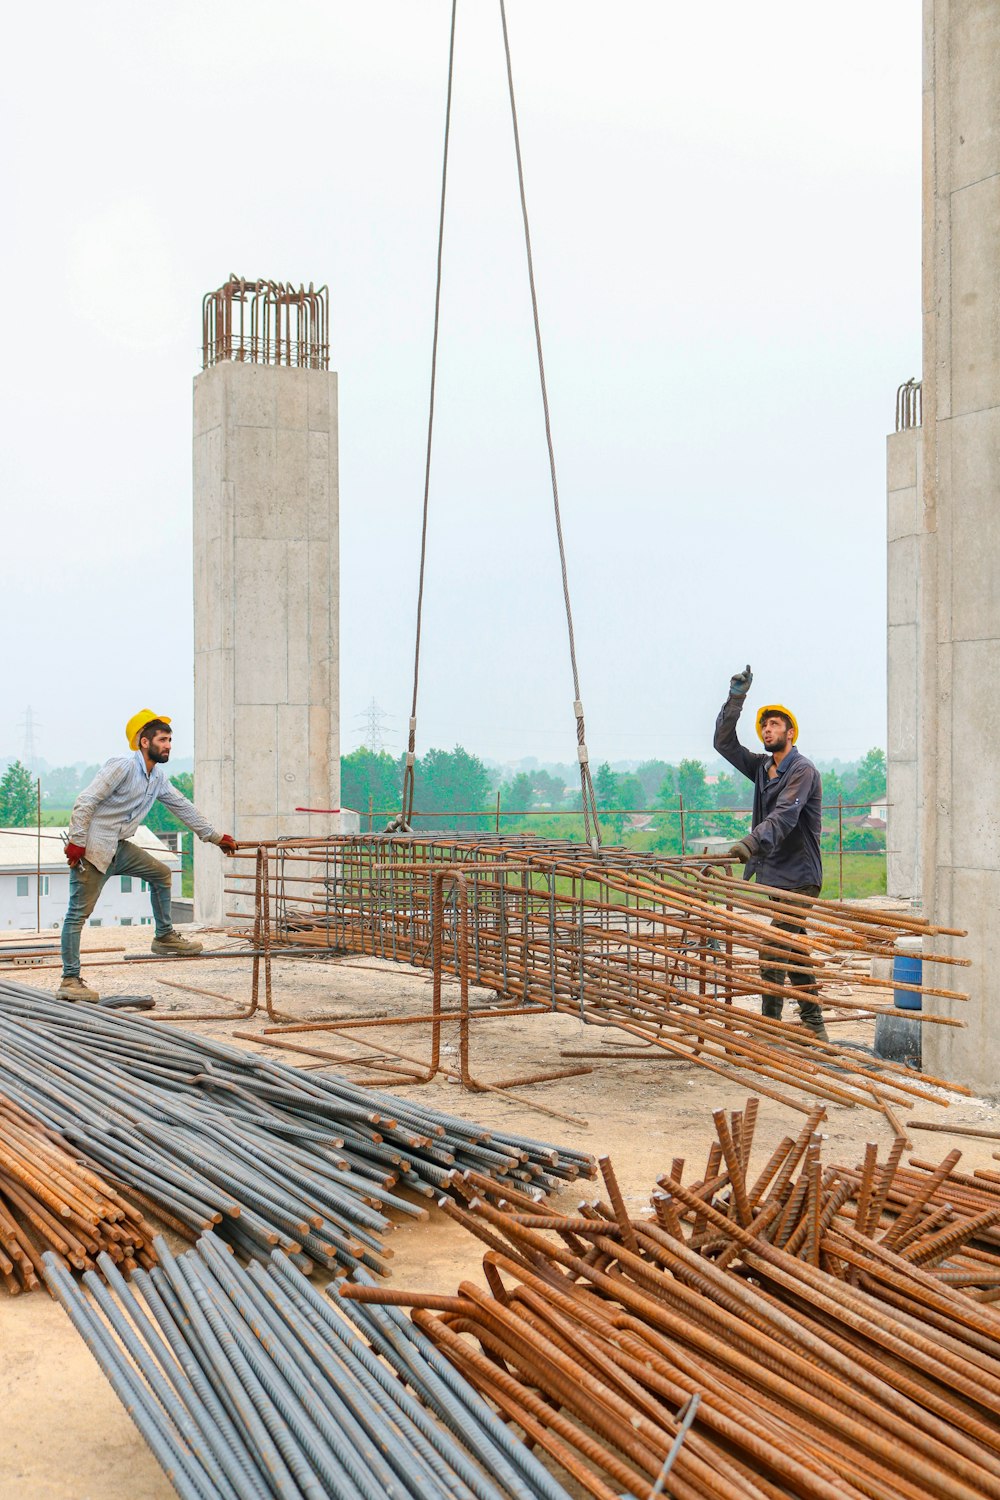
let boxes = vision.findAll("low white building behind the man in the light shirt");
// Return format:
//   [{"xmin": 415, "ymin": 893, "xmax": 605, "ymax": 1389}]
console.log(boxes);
[{"xmin": 0, "ymin": 825, "xmax": 181, "ymax": 932}]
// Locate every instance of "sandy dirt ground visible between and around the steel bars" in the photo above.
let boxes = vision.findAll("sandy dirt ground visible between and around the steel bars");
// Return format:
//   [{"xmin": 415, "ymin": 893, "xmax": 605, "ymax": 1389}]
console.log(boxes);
[{"xmin": 0, "ymin": 929, "xmax": 1000, "ymax": 1500}]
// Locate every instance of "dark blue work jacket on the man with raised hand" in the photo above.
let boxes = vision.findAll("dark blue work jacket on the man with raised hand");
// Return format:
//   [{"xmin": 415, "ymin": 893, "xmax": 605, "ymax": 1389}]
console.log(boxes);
[{"xmin": 715, "ymin": 696, "xmax": 823, "ymax": 891}]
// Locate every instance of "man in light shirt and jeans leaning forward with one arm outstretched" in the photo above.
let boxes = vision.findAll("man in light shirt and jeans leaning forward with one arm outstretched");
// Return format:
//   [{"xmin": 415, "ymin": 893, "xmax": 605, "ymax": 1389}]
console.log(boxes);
[{"xmin": 55, "ymin": 708, "xmax": 237, "ymax": 1001}]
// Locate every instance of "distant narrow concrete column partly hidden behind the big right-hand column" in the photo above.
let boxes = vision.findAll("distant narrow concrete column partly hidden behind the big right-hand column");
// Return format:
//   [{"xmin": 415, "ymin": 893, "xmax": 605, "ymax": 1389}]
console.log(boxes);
[{"xmin": 886, "ymin": 428, "xmax": 922, "ymax": 900}]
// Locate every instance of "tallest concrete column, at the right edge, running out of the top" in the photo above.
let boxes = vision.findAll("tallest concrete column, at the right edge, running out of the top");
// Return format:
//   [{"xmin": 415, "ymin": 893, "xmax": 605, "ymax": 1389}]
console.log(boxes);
[{"xmin": 919, "ymin": 0, "xmax": 1000, "ymax": 1092}]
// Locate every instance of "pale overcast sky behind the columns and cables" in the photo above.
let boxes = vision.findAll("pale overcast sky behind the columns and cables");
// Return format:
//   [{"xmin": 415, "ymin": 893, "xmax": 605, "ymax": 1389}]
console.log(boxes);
[{"xmin": 0, "ymin": 0, "xmax": 921, "ymax": 765}]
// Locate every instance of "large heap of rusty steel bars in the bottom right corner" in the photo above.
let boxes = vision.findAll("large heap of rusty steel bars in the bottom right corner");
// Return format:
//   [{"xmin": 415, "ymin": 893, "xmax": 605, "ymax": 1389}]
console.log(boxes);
[{"xmin": 340, "ymin": 1101, "xmax": 1000, "ymax": 1500}]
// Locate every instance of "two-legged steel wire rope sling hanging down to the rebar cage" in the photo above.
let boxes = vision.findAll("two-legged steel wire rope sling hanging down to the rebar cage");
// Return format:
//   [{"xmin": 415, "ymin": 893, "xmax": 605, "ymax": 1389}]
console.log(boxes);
[{"xmin": 395, "ymin": 0, "xmax": 601, "ymax": 854}]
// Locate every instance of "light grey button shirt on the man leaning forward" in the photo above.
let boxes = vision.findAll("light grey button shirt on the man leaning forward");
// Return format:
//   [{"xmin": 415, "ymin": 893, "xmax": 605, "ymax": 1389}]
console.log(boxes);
[{"xmin": 67, "ymin": 750, "xmax": 222, "ymax": 870}]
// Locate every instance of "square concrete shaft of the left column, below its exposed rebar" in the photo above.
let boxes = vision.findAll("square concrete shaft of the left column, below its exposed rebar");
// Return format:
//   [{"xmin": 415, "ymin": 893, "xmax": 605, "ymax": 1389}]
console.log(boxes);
[{"xmin": 193, "ymin": 363, "xmax": 340, "ymax": 924}]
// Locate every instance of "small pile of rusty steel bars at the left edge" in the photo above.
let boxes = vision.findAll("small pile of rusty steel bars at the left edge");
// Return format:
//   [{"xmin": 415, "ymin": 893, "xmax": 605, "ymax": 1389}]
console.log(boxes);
[{"xmin": 0, "ymin": 1094, "xmax": 153, "ymax": 1295}]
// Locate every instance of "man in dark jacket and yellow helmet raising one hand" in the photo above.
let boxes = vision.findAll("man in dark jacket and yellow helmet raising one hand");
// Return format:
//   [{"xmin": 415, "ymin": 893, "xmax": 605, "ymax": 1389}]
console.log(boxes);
[{"xmin": 715, "ymin": 666, "xmax": 829, "ymax": 1041}]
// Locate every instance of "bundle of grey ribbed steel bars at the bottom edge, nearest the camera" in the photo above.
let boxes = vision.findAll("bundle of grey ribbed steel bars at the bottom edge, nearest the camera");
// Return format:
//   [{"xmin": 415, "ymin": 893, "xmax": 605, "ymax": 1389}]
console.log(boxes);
[{"xmin": 45, "ymin": 1235, "xmax": 570, "ymax": 1500}]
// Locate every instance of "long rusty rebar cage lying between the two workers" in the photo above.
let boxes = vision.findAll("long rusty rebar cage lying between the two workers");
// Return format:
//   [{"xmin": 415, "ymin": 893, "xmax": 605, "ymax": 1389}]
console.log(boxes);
[{"xmin": 229, "ymin": 834, "xmax": 967, "ymax": 1110}]
